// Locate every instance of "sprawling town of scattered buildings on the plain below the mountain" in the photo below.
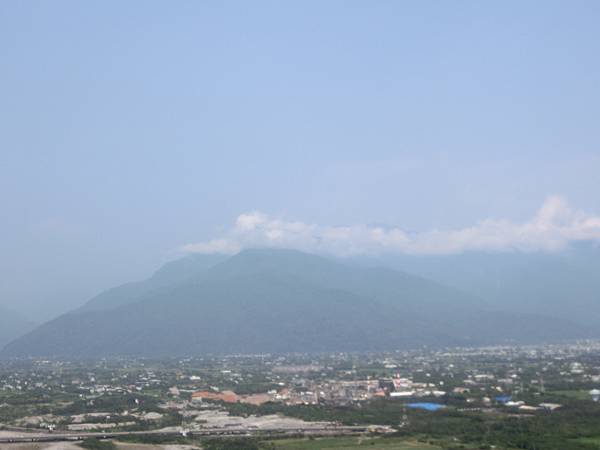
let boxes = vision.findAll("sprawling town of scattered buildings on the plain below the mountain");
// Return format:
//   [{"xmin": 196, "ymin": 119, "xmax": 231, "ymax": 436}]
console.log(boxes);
[{"xmin": 0, "ymin": 341, "xmax": 600, "ymax": 449}]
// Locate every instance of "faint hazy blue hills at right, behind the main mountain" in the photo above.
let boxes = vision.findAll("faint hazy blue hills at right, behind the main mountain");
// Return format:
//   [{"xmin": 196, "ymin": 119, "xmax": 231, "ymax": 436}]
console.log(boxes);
[{"xmin": 370, "ymin": 242, "xmax": 600, "ymax": 328}]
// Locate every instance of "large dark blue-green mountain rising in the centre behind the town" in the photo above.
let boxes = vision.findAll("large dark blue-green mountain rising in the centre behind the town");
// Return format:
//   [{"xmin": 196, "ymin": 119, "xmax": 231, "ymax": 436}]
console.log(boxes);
[{"xmin": 1, "ymin": 250, "xmax": 593, "ymax": 357}]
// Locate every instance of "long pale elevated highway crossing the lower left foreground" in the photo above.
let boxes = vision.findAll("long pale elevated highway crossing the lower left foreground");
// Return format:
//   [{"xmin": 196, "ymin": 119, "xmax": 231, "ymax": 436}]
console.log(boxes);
[{"xmin": 0, "ymin": 426, "xmax": 368, "ymax": 444}]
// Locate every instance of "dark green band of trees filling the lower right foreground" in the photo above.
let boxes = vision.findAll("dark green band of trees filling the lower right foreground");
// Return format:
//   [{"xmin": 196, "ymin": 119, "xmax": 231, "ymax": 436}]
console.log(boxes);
[{"xmin": 220, "ymin": 400, "xmax": 600, "ymax": 450}]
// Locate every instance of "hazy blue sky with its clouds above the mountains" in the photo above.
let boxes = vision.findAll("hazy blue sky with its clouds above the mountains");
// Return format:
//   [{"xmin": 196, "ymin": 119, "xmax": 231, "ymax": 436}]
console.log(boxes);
[{"xmin": 0, "ymin": 0, "xmax": 600, "ymax": 320}]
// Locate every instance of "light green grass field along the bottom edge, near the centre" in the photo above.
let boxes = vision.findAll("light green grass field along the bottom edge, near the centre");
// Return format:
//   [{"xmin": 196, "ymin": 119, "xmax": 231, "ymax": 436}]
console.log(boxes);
[{"xmin": 273, "ymin": 437, "xmax": 440, "ymax": 450}]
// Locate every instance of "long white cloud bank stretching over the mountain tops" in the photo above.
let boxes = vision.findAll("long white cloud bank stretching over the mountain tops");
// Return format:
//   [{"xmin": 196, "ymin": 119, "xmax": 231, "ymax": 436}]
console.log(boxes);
[{"xmin": 182, "ymin": 196, "xmax": 600, "ymax": 256}]
